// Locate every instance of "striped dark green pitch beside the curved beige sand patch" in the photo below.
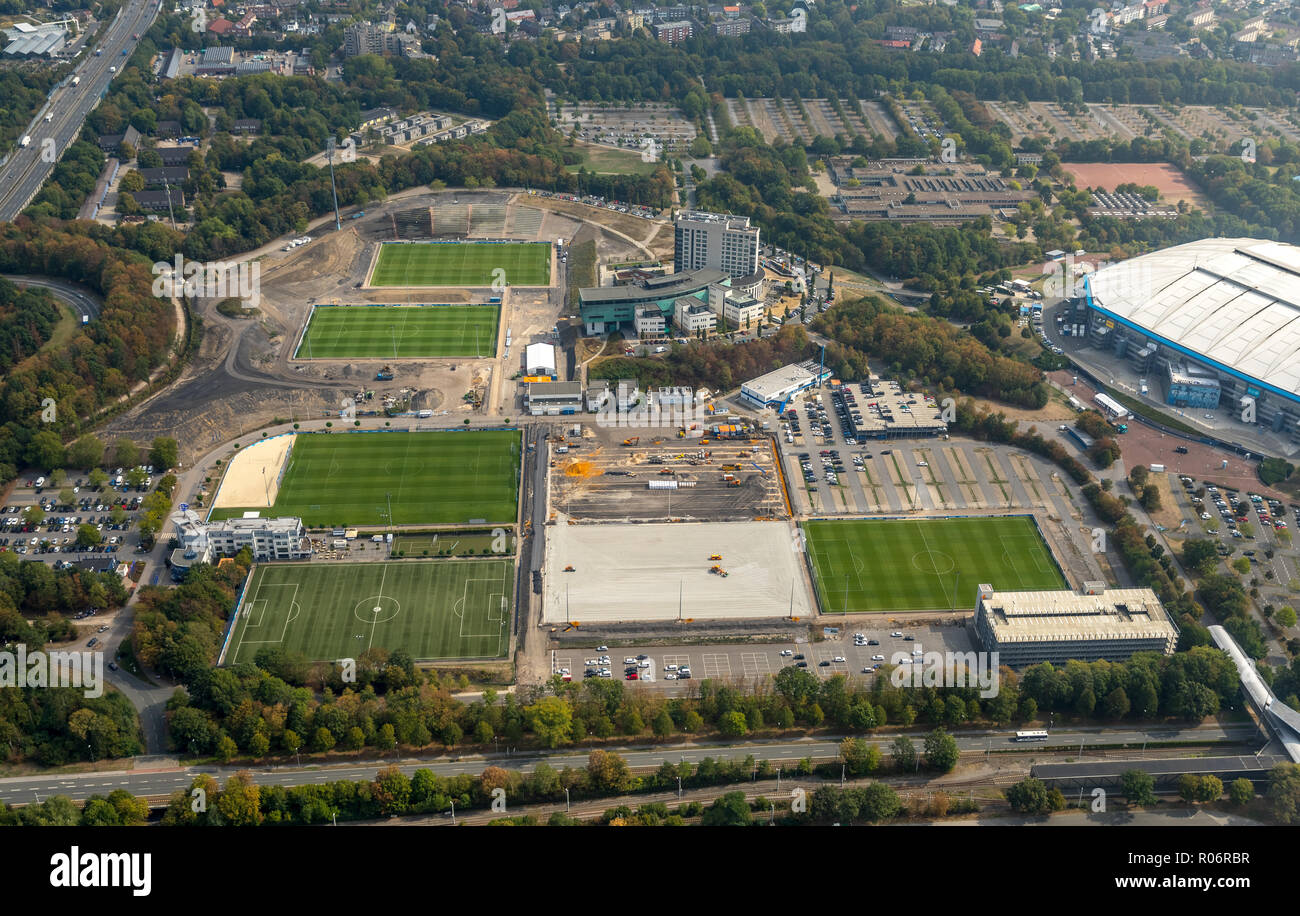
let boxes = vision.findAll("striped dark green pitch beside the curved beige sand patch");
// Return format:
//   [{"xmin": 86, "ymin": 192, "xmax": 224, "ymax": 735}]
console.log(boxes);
[{"xmin": 212, "ymin": 430, "xmax": 520, "ymax": 528}]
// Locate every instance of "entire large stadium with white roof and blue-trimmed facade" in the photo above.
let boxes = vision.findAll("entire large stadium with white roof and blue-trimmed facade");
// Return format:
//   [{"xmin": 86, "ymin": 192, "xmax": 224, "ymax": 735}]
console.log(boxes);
[{"xmin": 1076, "ymin": 239, "xmax": 1300, "ymax": 440}]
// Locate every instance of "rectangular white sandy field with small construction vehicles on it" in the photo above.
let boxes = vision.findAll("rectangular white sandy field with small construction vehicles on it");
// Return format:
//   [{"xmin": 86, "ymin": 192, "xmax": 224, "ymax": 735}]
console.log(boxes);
[{"xmin": 542, "ymin": 516, "xmax": 816, "ymax": 624}]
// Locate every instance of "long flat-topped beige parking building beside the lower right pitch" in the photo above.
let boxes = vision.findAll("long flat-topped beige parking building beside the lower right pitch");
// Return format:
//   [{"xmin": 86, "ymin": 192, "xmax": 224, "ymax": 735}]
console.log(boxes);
[{"xmin": 975, "ymin": 582, "xmax": 1178, "ymax": 668}]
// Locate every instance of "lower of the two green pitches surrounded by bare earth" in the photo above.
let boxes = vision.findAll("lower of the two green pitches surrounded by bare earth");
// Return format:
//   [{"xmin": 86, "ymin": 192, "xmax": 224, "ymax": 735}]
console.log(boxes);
[{"xmin": 294, "ymin": 305, "xmax": 501, "ymax": 360}]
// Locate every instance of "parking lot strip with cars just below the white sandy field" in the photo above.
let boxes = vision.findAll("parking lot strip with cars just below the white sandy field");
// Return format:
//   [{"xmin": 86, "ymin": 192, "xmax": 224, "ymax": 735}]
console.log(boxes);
[{"xmin": 551, "ymin": 618, "xmax": 976, "ymax": 693}]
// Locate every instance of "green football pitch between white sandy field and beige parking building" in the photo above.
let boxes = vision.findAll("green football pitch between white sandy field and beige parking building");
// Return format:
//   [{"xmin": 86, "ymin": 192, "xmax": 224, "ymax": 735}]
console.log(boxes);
[{"xmin": 803, "ymin": 516, "xmax": 1066, "ymax": 613}]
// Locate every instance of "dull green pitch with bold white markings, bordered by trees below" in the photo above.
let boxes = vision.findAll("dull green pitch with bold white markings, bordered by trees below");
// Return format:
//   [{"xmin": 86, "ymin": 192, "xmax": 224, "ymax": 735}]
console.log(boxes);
[{"xmin": 225, "ymin": 560, "xmax": 514, "ymax": 664}]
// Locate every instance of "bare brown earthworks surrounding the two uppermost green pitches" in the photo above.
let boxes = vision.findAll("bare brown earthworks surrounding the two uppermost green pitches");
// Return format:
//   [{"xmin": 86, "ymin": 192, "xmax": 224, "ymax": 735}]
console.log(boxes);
[{"xmin": 100, "ymin": 188, "xmax": 660, "ymax": 463}]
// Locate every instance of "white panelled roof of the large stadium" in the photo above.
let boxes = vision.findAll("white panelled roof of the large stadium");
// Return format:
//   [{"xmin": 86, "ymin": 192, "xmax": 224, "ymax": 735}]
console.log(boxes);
[{"xmin": 1087, "ymin": 239, "xmax": 1300, "ymax": 399}]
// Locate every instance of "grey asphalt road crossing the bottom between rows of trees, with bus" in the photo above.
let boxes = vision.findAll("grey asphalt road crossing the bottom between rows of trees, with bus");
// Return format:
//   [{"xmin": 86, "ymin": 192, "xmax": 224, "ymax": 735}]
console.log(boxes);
[{"xmin": 0, "ymin": 722, "xmax": 1258, "ymax": 804}]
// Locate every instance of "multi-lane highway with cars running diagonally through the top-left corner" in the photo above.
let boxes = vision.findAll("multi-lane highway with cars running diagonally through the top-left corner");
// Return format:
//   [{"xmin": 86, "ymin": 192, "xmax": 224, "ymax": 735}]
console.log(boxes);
[{"xmin": 0, "ymin": 0, "xmax": 160, "ymax": 222}]
